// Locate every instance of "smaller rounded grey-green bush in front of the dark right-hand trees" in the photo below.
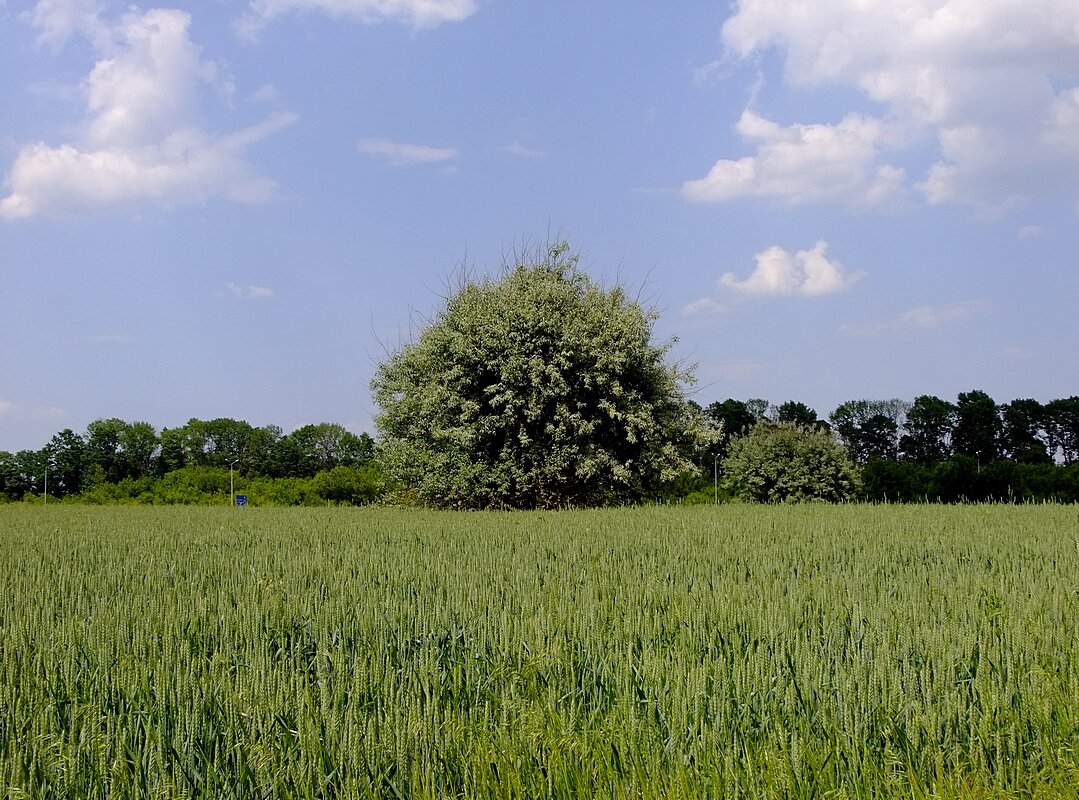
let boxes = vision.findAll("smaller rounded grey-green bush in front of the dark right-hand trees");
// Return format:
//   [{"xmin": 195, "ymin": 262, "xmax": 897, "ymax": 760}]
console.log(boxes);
[{"xmin": 723, "ymin": 421, "xmax": 859, "ymax": 503}]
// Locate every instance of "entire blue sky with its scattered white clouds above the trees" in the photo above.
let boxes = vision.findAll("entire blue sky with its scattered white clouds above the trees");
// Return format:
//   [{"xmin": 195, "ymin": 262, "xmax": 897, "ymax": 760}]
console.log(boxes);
[{"xmin": 0, "ymin": 0, "xmax": 1079, "ymax": 450}]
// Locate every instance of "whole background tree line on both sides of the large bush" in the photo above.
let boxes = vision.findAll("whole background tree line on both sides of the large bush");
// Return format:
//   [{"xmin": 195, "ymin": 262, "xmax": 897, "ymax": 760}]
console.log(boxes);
[{"xmin": 0, "ymin": 390, "xmax": 1079, "ymax": 504}]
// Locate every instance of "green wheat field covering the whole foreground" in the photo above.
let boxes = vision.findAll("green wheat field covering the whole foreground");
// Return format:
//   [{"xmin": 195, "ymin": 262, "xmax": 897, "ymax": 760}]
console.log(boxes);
[{"xmin": 0, "ymin": 505, "xmax": 1079, "ymax": 798}]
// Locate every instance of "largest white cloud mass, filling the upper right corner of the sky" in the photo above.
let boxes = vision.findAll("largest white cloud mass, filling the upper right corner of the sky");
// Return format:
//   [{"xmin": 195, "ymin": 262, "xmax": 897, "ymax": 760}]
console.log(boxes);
[{"xmin": 683, "ymin": 0, "xmax": 1079, "ymax": 206}]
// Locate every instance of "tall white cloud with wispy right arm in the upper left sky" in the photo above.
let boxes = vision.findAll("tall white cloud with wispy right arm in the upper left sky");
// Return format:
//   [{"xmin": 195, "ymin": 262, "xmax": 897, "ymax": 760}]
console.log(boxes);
[{"xmin": 0, "ymin": 6, "xmax": 297, "ymax": 219}]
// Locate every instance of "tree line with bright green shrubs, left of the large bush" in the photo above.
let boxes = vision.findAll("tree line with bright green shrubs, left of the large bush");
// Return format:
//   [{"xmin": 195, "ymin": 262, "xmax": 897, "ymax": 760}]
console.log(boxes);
[{"xmin": 0, "ymin": 418, "xmax": 384, "ymax": 504}]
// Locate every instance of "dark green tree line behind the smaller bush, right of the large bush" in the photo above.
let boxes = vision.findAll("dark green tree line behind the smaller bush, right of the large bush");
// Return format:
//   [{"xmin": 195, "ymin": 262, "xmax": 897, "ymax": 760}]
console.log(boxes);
[{"xmin": 695, "ymin": 390, "xmax": 1079, "ymax": 502}]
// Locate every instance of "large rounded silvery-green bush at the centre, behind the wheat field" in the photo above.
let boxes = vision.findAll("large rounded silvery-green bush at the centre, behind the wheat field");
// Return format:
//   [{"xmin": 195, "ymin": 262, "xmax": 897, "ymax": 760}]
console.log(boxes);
[{"xmin": 372, "ymin": 244, "xmax": 708, "ymax": 509}]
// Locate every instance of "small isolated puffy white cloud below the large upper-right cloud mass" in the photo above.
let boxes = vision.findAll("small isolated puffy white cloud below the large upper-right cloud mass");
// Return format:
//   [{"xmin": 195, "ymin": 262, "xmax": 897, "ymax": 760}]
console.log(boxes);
[{"xmin": 720, "ymin": 241, "xmax": 862, "ymax": 297}]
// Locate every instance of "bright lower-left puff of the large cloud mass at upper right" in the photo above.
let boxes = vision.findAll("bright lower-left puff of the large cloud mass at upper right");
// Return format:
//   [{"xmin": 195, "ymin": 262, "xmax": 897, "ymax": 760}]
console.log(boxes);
[{"xmin": 682, "ymin": 110, "xmax": 904, "ymax": 204}]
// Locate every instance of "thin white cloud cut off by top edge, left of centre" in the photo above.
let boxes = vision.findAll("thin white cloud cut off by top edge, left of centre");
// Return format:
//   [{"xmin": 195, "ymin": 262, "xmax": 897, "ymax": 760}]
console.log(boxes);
[{"xmin": 236, "ymin": 0, "xmax": 479, "ymax": 38}]
